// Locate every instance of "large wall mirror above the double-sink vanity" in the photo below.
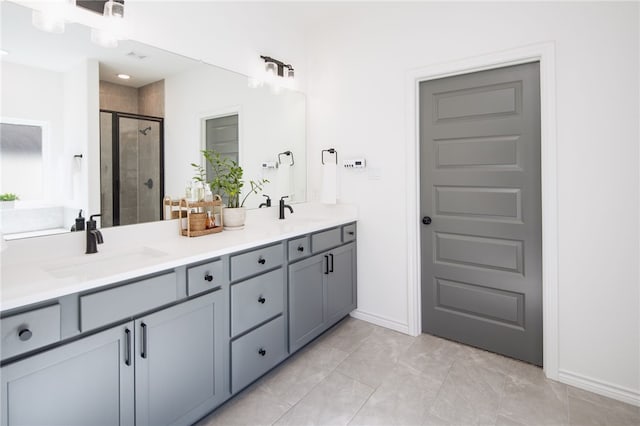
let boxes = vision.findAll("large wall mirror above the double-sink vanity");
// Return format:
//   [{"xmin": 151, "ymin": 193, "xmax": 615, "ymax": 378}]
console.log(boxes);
[{"xmin": 0, "ymin": 1, "xmax": 306, "ymax": 239}]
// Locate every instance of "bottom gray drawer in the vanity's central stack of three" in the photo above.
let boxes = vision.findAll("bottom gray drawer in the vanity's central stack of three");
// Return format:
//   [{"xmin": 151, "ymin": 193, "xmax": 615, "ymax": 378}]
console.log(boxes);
[{"xmin": 231, "ymin": 316, "xmax": 286, "ymax": 393}]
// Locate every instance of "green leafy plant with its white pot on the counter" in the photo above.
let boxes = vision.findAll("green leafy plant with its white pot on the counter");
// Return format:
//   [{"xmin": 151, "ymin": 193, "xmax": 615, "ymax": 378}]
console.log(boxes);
[{"xmin": 191, "ymin": 149, "xmax": 269, "ymax": 229}]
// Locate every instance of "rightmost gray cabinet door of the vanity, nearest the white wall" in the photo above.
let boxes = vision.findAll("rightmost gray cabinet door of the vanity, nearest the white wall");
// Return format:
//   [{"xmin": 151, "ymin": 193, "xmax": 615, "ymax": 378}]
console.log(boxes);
[{"xmin": 327, "ymin": 243, "xmax": 356, "ymax": 326}]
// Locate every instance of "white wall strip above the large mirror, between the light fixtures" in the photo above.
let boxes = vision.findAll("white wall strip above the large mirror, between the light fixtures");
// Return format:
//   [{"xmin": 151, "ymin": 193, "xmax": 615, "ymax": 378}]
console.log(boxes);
[{"xmin": 125, "ymin": 0, "xmax": 306, "ymax": 90}]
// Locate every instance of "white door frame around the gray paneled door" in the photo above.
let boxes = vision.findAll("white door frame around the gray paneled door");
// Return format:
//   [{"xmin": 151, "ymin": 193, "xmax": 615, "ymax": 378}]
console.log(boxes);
[{"xmin": 405, "ymin": 42, "xmax": 559, "ymax": 380}]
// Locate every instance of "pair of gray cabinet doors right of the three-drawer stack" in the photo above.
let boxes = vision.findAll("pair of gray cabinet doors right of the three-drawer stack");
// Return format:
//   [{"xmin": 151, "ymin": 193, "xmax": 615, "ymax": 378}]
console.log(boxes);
[{"xmin": 289, "ymin": 238, "xmax": 357, "ymax": 353}]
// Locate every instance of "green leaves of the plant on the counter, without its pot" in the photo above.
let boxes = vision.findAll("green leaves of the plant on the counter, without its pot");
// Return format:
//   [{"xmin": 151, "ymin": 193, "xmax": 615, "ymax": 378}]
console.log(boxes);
[{"xmin": 191, "ymin": 149, "xmax": 269, "ymax": 208}]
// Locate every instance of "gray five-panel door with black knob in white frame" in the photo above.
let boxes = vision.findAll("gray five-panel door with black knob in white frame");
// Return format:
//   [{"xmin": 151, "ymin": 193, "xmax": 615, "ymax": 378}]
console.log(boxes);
[{"xmin": 420, "ymin": 62, "xmax": 542, "ymax": 365}]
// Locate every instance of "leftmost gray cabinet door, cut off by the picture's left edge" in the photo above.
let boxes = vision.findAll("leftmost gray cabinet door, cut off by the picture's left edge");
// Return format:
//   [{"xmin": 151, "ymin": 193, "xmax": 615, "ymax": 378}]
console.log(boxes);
[{"xmin": 0, "ymin": 322, "xmax": 134, "ymax": 426}]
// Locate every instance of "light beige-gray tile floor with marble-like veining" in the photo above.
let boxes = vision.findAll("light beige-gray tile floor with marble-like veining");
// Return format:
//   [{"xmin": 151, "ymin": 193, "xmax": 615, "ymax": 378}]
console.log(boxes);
[{"xmin": 198, "ymin": 318, "xmax": 640, "ymax": 426}]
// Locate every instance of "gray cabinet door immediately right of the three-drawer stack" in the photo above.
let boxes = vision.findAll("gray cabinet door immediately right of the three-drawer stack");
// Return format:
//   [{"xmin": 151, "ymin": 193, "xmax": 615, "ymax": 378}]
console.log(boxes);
[{"xmin": 289, "ymin": 255, "xmax": 328, "ymax": 353}]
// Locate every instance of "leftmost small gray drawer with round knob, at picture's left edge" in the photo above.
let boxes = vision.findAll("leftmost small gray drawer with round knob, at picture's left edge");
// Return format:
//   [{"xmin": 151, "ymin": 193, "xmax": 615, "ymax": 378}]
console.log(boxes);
[{"xmin": 0, "ymin": 305, "xmax": 60, "ymax": 359}]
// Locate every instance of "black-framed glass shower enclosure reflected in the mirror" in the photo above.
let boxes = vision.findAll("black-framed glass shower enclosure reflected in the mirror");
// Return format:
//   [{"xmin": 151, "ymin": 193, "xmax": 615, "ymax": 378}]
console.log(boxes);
[{"xmin": 100, "ymin": 110, "xmax": 164, "ymax": 227}]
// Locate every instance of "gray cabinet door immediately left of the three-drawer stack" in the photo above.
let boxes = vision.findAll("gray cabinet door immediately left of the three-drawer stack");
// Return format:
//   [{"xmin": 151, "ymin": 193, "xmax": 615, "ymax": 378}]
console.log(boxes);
[{"xmin": 135, "ymin": 290, "xmax": 228, "ymax": 426}]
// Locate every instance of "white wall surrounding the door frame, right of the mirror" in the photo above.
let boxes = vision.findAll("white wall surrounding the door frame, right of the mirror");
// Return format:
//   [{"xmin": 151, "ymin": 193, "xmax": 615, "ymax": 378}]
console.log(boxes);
[{"xmin": 308, "ymin": 3, "xmax": 640, "ymax": 404}]
